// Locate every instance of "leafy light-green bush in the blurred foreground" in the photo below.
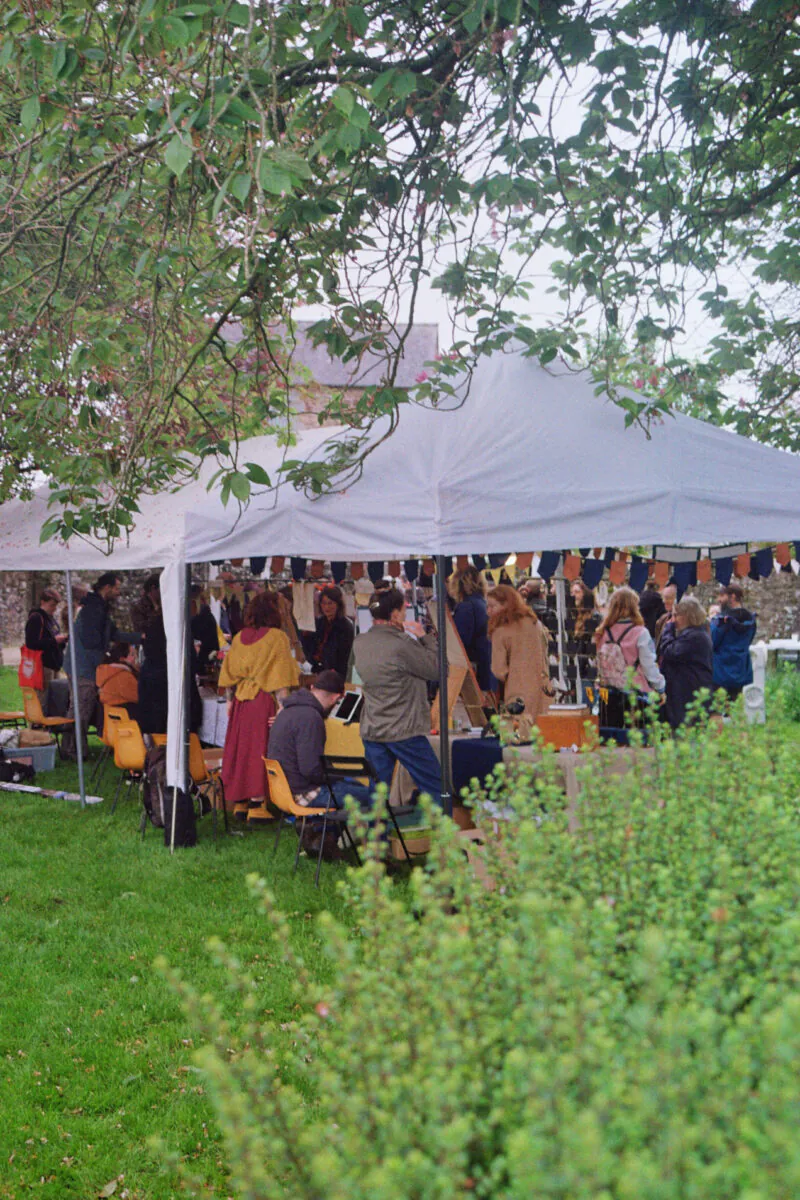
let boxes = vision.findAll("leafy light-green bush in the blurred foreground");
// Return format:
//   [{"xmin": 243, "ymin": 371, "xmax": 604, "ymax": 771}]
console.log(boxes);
[{"xmin": 160, "ymin": 722, "xmax": 800, "ymax": 1200}]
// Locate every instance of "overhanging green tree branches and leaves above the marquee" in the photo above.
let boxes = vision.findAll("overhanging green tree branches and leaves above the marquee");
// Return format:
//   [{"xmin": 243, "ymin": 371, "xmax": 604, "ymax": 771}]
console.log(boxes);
[{"xmin": 0, "ymin": 0, "xmax": 800, "ymax": 542}]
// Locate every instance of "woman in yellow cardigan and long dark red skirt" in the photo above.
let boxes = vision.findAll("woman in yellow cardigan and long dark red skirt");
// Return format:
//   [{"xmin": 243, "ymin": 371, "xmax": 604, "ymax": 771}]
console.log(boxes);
[{"xmin": 219, "ymin": 592, "xmax": 300, "ymax": 808}]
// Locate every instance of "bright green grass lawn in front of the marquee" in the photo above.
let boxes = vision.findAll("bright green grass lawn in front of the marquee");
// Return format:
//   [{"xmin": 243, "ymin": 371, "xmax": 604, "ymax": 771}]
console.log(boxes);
[{"xmin": 0, "ymin": 668, "xmax": 350, "ymax": 1200}]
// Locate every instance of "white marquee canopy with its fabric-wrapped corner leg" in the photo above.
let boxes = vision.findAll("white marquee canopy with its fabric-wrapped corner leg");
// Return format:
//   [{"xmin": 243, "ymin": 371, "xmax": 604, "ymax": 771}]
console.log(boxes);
[{"xmin": 0, "ymin": 353, "xmax": 800, "ymax": 801}]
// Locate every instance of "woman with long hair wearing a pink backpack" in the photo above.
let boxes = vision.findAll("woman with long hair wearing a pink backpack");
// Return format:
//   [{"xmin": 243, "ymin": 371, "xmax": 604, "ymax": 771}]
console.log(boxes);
[{"xmin": 595, "ymin": 588, "xmax": 664, "ymax": 728}]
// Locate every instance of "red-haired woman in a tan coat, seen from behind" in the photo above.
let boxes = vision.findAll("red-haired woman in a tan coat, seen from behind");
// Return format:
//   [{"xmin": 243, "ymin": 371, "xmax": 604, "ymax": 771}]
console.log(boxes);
[{"xmin": 486, "ymin": 583, "xmax": 551, "ymax": 719}]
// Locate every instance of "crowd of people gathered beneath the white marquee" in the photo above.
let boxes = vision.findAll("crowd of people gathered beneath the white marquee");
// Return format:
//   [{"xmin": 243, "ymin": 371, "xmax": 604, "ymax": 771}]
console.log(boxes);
[{"xmin": 25, "ymin": 564, "xmax": 757, "ymax": 844}]
